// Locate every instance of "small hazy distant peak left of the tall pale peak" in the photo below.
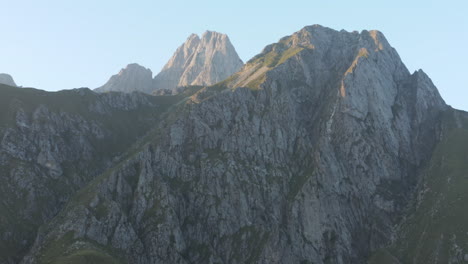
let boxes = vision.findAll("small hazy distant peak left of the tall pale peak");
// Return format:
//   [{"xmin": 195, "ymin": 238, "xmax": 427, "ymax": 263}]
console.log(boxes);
[{"xmin": 95, "ymin": 63, "xmax": 153, "ymax": 93}]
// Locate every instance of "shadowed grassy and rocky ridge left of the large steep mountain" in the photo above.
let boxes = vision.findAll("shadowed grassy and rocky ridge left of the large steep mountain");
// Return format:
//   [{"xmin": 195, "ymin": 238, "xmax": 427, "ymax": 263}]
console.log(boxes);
[{"xmin": 0, "ymin": 85, "xmax": 197, "ymax": 263}]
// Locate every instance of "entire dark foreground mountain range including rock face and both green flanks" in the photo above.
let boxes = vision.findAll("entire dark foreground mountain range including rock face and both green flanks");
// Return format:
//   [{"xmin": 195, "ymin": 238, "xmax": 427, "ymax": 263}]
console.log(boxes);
[{"xmin": 0, "ymin": 25, "xmax": 468, "ymax": 264}]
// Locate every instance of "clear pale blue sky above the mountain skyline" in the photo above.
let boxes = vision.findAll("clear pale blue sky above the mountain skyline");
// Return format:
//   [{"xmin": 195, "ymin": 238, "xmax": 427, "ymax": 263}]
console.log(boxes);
[{"xmin": 0, "ymin": 0, "xmax": 468, "ymax": 110}]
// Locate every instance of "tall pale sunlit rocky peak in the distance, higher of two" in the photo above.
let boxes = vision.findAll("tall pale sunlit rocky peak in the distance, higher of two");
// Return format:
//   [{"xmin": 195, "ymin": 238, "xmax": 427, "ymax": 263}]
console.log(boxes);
[{"xmin": 154, "ymin": 31, "xmax": 243, "ymax": 90}]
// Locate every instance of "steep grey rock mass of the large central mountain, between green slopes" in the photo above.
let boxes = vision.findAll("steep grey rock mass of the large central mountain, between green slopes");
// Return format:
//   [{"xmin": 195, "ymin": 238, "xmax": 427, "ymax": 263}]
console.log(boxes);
[{"xmin": 18, "ymin": 26, "xmax": 454, "ymax": 263}]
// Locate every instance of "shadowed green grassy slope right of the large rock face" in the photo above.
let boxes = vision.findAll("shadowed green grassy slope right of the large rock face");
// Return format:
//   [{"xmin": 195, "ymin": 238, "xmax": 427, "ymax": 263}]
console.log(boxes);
[{"xmin": 369, "ymin": 111, "xmax": 468, "ymax": 264}]
